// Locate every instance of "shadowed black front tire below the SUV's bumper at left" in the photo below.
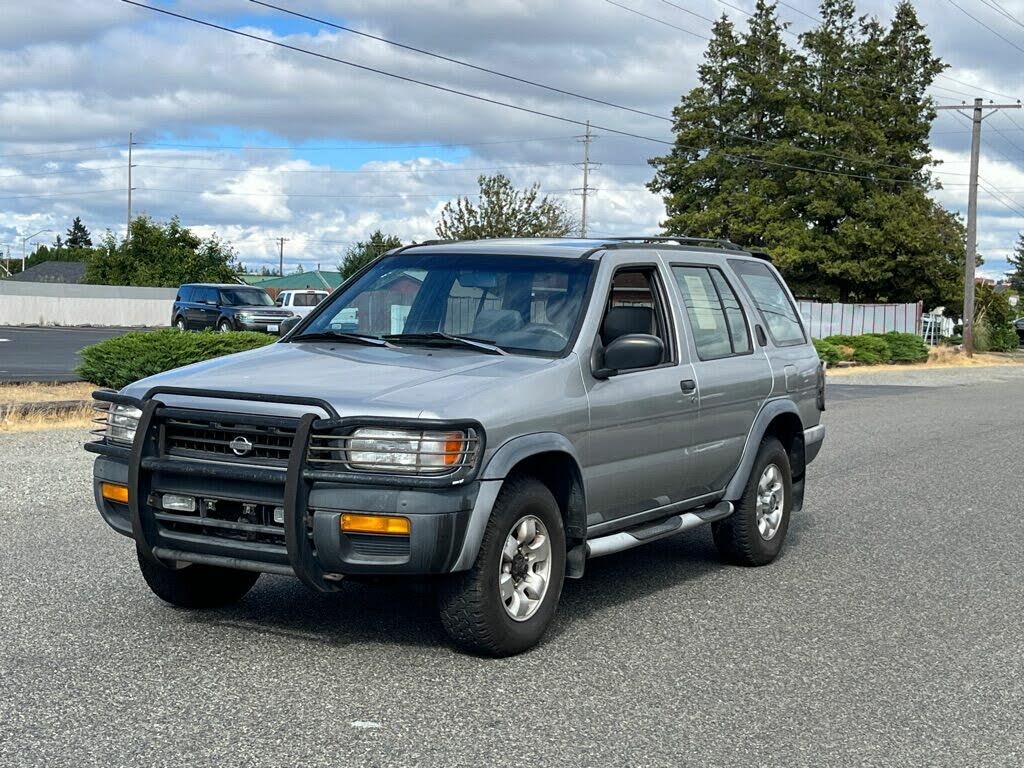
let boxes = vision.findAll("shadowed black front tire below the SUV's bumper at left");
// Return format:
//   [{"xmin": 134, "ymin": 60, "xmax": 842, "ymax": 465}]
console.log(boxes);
[{"xmin": 137, "ymin": 553, "xmax": 259, "ymax": 608}]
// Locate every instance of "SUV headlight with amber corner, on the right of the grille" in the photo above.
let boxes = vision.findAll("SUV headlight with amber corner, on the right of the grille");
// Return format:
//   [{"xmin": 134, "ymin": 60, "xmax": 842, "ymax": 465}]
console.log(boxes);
[{"xmin": 342, "ymin": 427, "xmax": 476, "ymax": 474}]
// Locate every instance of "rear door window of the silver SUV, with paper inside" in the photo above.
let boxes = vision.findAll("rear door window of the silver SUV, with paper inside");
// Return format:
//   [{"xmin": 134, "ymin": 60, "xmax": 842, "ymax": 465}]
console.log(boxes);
[{"xmin": 672, "ymin": 266, "xmax": 753, "ymax": 360}]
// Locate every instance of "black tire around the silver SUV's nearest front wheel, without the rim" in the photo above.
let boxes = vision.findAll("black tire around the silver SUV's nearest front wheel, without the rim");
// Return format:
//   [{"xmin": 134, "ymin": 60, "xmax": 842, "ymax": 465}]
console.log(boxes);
[{"xmin": 440, "ymin": 477, "xmax": 565, "ymax": 656}]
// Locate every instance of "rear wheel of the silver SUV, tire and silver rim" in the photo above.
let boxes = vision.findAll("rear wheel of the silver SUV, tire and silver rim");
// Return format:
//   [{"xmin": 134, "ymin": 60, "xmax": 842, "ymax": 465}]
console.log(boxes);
[{"xmin": 712, "ymin": 437, "xmax": 793, "ymax": 565}]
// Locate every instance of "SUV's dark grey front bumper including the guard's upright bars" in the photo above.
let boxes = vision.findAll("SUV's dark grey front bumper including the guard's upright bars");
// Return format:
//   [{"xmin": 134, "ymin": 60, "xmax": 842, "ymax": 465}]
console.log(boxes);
[{"xmin": 86, "ymin": 387, "xmax": 487, "ymax": 592}]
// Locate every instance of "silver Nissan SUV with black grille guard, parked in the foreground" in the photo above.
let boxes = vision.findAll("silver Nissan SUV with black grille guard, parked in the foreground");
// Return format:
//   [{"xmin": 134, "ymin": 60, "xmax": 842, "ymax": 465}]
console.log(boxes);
[{"xmin": 87, "ymin": 238, "xmax": 824, "ymax": 655}]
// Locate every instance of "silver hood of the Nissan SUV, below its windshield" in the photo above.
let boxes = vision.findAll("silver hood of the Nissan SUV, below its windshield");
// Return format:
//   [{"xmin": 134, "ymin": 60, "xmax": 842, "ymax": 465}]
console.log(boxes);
[{"xmin": 124, "ymin": 342, "xmax": 564, "ymax": 417}]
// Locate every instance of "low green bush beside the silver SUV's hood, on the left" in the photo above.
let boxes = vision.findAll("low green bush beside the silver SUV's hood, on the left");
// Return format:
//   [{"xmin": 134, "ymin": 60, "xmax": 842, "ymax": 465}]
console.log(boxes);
[{"xmin": 77, "ymin": 329, "xmax": 275, "ymax": 389}]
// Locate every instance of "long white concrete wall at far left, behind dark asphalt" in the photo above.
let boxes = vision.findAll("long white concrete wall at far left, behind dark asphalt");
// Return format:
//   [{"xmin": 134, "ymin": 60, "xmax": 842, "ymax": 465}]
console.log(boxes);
[{"xmin": 0, "ymin": 280, "xmax": 177, "ymax": 328}]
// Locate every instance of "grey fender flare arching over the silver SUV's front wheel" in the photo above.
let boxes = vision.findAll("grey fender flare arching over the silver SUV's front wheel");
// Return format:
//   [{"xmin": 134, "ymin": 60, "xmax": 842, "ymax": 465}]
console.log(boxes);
[{"xmin": 452, "ymin": 432, "xmax": 587, "ymax": 571}]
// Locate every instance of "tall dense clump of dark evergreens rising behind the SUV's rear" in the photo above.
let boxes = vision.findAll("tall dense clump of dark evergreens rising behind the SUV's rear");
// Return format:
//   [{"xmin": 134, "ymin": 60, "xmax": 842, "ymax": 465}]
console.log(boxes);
[{"xmin": 650, "ymin": 0, "xmax": 965, "ymax": 306}]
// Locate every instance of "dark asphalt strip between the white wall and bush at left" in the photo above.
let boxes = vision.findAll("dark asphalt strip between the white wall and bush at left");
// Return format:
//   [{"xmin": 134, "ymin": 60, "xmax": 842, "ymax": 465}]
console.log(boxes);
[{"xmin": 0, "ymin": 327, "xmax": 149, "ymax": 383}]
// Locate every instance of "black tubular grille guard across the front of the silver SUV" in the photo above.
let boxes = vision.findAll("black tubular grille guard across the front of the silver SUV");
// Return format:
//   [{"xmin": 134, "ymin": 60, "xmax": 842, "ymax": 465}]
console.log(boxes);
[{"xmin": 85, "ymin": 387, "xmax": 485, "ymax": 592}]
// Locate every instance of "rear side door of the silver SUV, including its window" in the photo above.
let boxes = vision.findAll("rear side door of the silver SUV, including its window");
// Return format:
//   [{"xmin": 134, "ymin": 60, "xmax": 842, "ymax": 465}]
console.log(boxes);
[{"xmin": 672, "ymin": 263, "xmax": 772, "ymax": 496}]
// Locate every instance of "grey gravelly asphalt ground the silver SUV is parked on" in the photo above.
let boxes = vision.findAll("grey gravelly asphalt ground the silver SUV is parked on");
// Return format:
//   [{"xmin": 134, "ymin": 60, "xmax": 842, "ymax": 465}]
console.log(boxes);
[{"xmin": 0, "ymin": 367, "xmax": 1024, "ymax": 766}]
